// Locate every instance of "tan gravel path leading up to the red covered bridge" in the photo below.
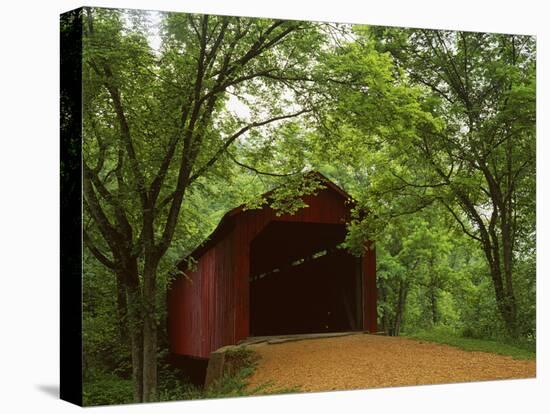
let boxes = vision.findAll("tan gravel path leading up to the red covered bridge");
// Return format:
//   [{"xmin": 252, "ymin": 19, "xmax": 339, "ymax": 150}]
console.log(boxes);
[{"xmin": 250, "ymin": 335, "xmax": 535, "ymax": 391}]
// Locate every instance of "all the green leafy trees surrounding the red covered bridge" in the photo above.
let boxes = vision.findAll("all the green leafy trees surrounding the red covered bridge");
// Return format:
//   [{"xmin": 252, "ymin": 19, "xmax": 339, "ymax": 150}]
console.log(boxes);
[{"xmin": 67, "ymin": 8, "xmax": 536, "ymax": 404}]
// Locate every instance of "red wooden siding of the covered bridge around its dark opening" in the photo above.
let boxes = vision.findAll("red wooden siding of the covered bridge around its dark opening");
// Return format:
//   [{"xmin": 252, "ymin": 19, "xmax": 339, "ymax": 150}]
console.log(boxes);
[{"xmin": 168, "ymin": 181, "xmax": 376, "ymax": 358}]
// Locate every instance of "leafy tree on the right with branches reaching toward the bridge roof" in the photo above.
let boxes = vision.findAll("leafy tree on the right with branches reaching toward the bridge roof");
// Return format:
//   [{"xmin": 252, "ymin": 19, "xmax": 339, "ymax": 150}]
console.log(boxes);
[{"xmin": 316, "ymin": 27, "xmax": 535, "ymax": 337}]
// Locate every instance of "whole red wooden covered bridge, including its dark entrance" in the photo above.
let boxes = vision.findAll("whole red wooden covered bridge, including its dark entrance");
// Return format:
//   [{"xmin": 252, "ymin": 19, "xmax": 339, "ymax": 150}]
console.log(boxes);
[{"xmin": 168, "ymin": 174, "xmax": 376, "ymax": 358}]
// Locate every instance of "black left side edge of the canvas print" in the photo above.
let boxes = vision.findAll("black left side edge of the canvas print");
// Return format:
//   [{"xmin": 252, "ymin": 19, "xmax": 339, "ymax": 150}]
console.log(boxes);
[{"xmin": 59, "ymin": 7, "xmax": 83, "ymax": 406}]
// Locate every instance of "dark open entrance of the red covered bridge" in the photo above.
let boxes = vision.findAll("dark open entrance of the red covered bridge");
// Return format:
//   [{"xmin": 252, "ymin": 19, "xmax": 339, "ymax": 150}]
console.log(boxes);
[{"xmin": 250, "ymin": 221, "xmax": 363, "ymax": 336}]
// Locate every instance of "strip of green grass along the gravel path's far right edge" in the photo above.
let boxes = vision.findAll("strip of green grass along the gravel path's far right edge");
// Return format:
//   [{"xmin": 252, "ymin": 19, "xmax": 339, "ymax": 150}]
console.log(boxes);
[{"xmin": 405, "ymin": 328, "xmax": 536, "ymax": 359}]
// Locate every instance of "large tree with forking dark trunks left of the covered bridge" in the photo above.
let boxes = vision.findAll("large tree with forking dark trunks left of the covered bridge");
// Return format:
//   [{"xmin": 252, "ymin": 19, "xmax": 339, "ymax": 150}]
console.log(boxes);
[{"xmin": 83, "ymin": 9, "xmax": 326, "ymax": 401}]
